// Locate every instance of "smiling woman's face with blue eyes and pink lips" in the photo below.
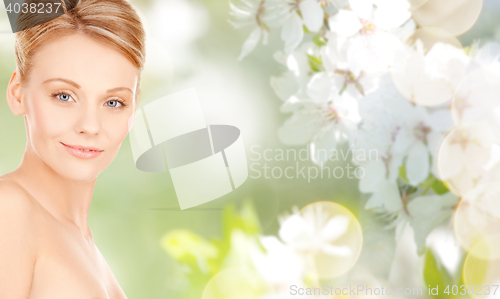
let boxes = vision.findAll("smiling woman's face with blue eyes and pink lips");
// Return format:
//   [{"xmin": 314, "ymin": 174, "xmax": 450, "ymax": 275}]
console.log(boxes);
[{"xmin": 22, "ymin": 34, "xmax": 140, "ymax": 182}]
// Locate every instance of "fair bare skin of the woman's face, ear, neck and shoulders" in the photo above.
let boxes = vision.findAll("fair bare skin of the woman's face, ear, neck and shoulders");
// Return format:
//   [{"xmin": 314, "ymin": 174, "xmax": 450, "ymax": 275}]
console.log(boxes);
[{"xmin": 0, "ymin": 34, "xmax": 140, "ymax": 299}]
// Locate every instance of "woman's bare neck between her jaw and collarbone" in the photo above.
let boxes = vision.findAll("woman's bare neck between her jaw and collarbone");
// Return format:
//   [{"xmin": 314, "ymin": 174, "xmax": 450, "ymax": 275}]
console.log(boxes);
[{"xmin": 13, "ymin": 145, "xmax": 96, "ymax": 239}]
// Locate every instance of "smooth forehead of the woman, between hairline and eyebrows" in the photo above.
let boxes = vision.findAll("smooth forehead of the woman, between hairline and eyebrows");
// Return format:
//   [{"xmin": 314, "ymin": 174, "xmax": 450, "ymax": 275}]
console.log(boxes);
[{"xmin": 30, "ymin": 34, "xmax": 140, "ymax": 90}]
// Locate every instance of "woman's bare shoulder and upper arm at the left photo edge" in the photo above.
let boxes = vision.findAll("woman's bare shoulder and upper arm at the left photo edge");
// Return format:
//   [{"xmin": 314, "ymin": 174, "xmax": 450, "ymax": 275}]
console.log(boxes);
[{"xmin": 0, "ymin": 177, "xmax": 37, "ymax": 298}]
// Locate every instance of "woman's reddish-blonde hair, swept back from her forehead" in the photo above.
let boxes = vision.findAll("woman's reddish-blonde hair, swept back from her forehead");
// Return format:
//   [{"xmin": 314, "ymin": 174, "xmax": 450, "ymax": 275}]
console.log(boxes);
[{"xmin": 15, "ymin": 0, "xmax": 146, "ymax": 92}]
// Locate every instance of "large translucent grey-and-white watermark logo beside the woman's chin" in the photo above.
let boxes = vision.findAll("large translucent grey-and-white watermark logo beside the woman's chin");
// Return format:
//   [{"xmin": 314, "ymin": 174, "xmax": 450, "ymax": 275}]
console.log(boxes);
[{"xmin": 129, "ymin": 88, "xmax": 248, "ymax": 210}]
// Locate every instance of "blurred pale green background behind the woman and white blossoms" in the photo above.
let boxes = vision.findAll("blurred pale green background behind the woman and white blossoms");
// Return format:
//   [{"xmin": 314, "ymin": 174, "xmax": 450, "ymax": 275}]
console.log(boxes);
[{"xmin": 0, "ymin": 0, "xmax": 500, "ymax": 299}]
